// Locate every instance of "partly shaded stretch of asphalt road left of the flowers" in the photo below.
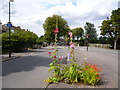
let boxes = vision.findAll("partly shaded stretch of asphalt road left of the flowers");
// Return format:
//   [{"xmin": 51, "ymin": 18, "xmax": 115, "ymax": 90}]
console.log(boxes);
[{"xmin": 2, "ymin": 49, "xmax": 51, "ymax": 88}]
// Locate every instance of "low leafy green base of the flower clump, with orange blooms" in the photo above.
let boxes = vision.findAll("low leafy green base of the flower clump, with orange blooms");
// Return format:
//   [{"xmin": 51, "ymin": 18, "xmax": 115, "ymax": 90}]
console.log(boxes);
[{"xmin": 46, "ymin": 59, "xmax": 100, "ymax": 85}]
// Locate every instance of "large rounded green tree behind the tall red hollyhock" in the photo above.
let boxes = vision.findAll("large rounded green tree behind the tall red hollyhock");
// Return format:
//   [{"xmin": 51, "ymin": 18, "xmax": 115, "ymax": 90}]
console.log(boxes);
[{"xmin": 43, "ymin": 15, "xmax": 69, "ymax": 42}]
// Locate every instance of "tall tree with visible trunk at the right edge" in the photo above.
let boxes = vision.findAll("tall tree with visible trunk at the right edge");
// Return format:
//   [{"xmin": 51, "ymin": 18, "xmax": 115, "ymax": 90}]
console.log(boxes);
[{"xmin": 100, "ymin": 8, "xmax": 120, "ymax": 49}]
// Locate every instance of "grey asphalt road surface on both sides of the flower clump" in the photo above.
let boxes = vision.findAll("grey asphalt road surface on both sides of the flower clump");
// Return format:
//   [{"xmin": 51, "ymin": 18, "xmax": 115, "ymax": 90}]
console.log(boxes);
[{"xmin": 2, "ymin": 47, "xmax": 118, "ymax": 88}]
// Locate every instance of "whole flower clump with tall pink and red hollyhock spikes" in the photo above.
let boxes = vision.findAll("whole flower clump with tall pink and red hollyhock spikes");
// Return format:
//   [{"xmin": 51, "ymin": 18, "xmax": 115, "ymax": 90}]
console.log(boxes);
[{"xmin": 46, "ymin": 29, "xmax": 101, "ymax": 85}]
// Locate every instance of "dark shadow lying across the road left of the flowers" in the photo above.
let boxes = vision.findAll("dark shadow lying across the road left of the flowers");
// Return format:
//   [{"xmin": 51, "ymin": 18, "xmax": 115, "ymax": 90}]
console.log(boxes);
[{"xmin": 2, "ymin": 55, "xmax": 51, "ymax": 76}]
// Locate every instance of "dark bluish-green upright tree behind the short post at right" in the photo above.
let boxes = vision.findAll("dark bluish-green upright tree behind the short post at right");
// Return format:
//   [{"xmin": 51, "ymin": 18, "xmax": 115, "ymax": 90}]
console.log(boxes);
[{"xmin": 84, "ymin": 22, "xmax": 97, "ymax": 43}]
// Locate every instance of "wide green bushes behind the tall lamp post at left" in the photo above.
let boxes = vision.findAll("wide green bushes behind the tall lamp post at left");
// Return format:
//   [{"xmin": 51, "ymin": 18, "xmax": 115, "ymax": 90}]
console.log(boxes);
[{"xmin": 0, "ymin": 29, "xmax": 37, "ymax": 53}]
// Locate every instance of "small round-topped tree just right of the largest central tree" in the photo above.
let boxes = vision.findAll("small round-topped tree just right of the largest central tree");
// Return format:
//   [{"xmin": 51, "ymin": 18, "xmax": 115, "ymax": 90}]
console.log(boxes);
[{"xmin": 72, "ymin": 27, "xmax": 84, "ymax": 41}]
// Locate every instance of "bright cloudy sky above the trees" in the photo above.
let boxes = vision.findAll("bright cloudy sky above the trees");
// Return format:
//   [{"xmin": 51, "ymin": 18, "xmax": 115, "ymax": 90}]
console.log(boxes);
[{"xmin": 0, "ymin": 0, "xmax": 120, "ymax": 36}]
